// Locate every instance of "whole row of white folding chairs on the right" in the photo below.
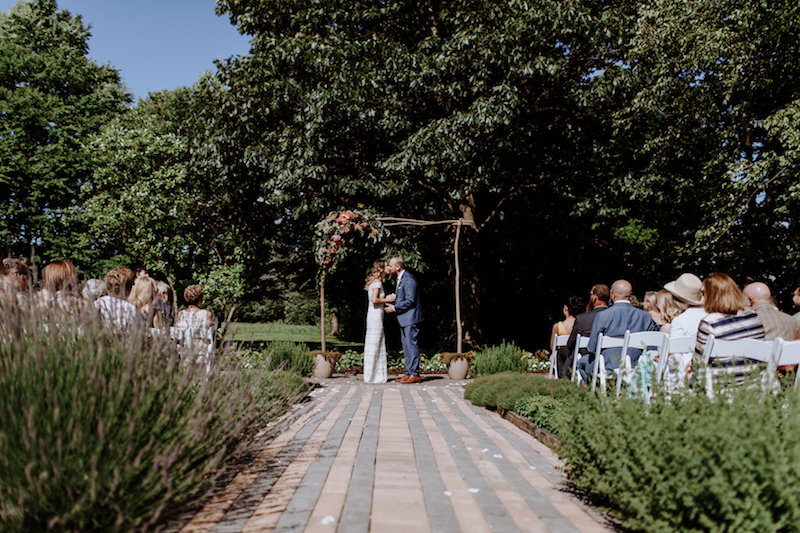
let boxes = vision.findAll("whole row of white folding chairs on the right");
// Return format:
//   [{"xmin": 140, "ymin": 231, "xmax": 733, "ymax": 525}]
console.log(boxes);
[{"xmin": 550, "ymin": 331, "xmax": 800, "ymax": 397}]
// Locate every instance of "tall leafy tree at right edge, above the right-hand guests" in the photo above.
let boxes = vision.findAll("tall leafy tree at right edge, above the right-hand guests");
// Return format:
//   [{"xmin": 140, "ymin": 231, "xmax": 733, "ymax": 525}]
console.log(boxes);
[{"xmin": 585, "ymin": 0, "xmax": 800, "ymax": 290}]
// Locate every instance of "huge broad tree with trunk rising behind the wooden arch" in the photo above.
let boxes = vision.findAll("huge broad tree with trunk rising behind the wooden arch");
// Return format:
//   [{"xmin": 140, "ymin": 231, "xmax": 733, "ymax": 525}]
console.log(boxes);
[{"xmin": 212, "ymin": 0, "xmax": 627, "ymax": 340}]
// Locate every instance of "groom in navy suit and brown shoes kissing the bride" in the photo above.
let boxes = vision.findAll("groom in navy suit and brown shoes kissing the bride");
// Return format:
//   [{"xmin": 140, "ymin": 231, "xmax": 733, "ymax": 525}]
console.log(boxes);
[{"xmin": 386, "ymin": 257, "xmax": 425, "ymax": 383}]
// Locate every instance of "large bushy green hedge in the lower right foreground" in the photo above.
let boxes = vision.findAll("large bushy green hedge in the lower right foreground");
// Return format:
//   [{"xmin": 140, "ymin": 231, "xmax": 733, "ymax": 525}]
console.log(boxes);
[{"xmin": 556, "ymin": 387, "xmax": 800, "ymax": 533}]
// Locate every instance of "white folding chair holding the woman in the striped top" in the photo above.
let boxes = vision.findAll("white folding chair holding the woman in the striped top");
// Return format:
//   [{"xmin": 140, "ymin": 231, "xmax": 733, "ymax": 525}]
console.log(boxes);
[{"xmin": 702, "ymin": 335, "xmax": 780, "ymax": 399}]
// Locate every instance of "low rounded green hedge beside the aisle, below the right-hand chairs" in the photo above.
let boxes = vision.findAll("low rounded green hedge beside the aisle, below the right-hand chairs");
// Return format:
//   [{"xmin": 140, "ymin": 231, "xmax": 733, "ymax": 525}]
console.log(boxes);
[{"xmin": 464, "ymin": 372, "xmax": 586, "ymax": 409}]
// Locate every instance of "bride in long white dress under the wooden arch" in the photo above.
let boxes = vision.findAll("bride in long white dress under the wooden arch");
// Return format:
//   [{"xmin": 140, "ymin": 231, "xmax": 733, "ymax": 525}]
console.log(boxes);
[{"xmin": 364, "ymin": 259, "xmax": 395, "ymax": 383}]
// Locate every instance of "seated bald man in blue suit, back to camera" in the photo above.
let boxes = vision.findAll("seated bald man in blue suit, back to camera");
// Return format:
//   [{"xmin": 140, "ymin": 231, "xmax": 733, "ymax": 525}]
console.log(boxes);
[{"xmin": 578, "ymin": 279, "xmax": 661, "ymax": 382}]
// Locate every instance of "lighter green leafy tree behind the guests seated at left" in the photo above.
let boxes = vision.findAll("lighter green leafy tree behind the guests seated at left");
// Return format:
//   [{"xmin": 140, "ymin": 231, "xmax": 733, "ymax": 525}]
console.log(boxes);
[{"xmin": 72, "ymin": 82, "xmax": 276, "ymax": 310}]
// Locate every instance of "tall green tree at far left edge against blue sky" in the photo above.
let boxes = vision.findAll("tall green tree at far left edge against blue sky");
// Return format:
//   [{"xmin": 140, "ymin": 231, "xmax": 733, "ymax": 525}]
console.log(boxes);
[{"xmin": 0, "ymin": 0, "xmax": 131, "ymax": 257}]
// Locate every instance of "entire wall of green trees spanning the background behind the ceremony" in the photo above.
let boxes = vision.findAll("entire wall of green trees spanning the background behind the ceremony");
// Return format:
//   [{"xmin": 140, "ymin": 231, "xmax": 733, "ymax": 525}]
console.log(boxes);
[{"xmin": 0, "ymin": 0, "xmax": 800, "ymax": 342}]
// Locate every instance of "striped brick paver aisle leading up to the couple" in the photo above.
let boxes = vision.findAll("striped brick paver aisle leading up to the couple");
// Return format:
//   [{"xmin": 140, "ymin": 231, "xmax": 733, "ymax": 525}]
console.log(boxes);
[{"xmin": 173, "ymin": 378, "xmax": 612, "ymax": 533}]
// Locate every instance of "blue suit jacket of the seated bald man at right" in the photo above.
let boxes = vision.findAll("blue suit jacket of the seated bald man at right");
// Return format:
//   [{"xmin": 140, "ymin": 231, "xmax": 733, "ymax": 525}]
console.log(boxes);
[{"xmin": 587, "ymin": 300, "xmax": 661, "ymax": 369}]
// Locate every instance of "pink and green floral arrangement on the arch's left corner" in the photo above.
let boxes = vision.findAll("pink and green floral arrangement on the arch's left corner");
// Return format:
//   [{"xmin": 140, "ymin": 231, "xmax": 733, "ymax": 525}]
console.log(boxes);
[{"xmin": 314, "ymin": 209, "xmax": 388, "ymax": 273}]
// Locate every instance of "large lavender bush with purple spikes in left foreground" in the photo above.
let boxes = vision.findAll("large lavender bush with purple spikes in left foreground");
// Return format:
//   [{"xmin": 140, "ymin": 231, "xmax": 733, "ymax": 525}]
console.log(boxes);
[{"xmin": 0, "ymin": 308, "xmax": 308, "ymax": 532}]
